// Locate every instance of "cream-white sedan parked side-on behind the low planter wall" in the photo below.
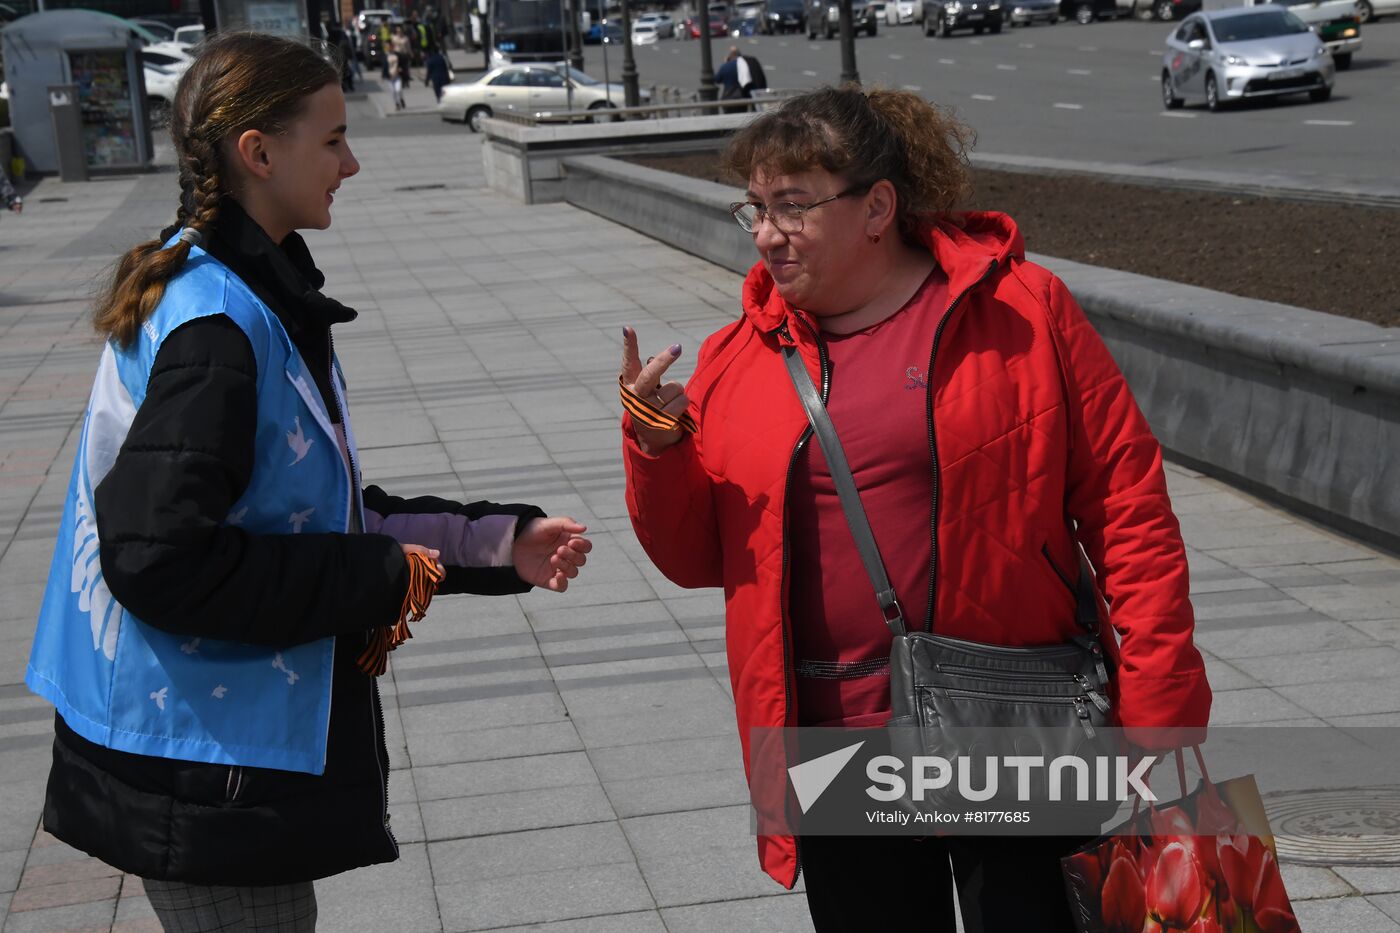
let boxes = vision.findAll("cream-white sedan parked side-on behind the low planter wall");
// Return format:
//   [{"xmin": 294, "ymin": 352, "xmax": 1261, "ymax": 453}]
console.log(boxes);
[{"xmin": 438, "ymin": 64, "xmax": 623, "ymax": 133}]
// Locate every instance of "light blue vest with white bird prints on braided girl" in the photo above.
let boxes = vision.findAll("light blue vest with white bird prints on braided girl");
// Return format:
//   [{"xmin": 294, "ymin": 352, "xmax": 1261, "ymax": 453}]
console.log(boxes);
[{"xmin": 25, "ymin": 239, "xmax": 364, "ymax": 775}]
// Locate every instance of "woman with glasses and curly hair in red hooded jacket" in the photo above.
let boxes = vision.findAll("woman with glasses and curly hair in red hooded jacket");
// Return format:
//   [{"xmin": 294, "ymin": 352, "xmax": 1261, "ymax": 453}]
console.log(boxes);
[{"xmin": 622, "ymin": 88, "xmax": 1211, "ymax": 933}]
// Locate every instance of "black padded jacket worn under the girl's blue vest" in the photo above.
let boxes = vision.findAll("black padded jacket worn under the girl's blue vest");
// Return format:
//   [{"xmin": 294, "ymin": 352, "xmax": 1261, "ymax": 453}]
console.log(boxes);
[{"xmin": 43, "ymin": 199, "xmax": 543, "ymax": 885}]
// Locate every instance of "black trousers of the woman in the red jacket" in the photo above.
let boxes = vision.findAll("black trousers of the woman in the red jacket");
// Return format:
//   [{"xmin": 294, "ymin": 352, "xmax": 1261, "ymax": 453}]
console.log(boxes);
[{"xmin": 799, "ymin": 836, "xmax": 1088, "ymax": 933}]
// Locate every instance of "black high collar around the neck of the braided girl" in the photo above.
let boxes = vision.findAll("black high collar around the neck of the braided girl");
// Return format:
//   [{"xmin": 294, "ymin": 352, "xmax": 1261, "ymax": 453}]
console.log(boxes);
[{"xmin": 161, "ymin": 198, "xmax": 356, "ymax": 345}]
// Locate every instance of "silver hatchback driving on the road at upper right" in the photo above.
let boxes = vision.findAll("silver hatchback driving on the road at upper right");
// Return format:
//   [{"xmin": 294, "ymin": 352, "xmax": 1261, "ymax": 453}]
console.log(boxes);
[{"xmin": 1162, "ymin": 4, "xmax": 1336, "ymax": 111}]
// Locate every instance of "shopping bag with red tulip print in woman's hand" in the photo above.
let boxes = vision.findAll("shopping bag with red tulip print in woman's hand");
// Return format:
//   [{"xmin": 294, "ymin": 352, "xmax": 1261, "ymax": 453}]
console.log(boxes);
[{"xmin": 1063, "ymin": 749, "xmax": 1301, "ymax": 933}]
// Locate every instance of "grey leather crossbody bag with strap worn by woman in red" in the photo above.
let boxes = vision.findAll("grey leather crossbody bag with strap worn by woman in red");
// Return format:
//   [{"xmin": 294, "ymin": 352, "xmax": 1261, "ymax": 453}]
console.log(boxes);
[{"xmin": 783, "ymin": 346, "xmax": 1116, "ymax": 807}]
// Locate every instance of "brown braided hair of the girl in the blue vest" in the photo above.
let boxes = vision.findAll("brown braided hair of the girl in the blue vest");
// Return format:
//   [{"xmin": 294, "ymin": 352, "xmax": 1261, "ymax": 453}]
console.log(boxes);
[{"xmin": 92, "ymin": 32, "xmax": 340, "ymax": 347}]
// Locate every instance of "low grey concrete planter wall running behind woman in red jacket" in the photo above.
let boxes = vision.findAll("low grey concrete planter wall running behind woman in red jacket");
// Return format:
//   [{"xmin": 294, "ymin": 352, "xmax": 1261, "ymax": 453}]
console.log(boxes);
[{"xmin": 563, "ymin": 149, "xmax": 1400, "ymax": 549}]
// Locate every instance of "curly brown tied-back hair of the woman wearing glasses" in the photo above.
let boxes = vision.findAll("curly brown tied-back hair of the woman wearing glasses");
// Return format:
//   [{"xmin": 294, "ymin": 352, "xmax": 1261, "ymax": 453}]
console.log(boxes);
[{"xmin": 724, "ymin": 84, "xmax": 976, "ymax": 244}]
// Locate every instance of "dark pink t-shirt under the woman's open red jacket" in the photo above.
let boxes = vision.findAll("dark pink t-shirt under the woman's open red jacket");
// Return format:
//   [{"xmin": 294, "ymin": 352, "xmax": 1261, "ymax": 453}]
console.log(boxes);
[{"xmin": 788, "ymin": 269, "xmax": 948, "ymax": 727}]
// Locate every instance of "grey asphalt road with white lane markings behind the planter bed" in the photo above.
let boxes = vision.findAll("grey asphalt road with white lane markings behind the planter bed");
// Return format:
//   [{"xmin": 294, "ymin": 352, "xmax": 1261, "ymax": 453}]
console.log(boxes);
[{"xmin": 565, "ymin": 17, "xmax": 1400, "ymax": 192}]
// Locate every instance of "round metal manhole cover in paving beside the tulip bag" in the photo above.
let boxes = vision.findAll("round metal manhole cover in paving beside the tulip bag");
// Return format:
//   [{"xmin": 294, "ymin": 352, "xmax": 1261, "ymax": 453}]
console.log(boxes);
[{"xmin": 1264, "ymin": 787, "xmax": 1400, "ymax": 867}]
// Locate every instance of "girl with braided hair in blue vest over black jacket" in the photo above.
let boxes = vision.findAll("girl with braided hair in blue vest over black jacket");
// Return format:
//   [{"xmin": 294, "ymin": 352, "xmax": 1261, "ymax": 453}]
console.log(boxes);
[{"xmin": 27, "ymin": 35, "xmax": 591, "ymax": 932}]
